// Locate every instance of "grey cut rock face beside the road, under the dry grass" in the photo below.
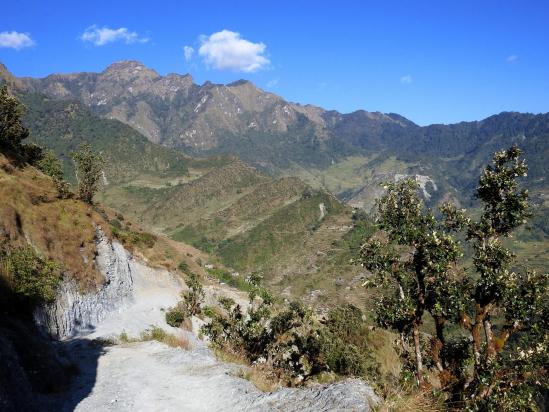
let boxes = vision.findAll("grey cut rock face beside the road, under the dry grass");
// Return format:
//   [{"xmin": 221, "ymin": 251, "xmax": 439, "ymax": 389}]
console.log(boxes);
[{"xmin": 34, "ymin": 229, "xmax": 137, "ymax": 339}]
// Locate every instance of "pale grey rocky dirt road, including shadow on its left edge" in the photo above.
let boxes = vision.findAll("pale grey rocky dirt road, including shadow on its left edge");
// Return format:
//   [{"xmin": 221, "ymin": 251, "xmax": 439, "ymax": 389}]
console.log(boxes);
[{"xmin": 49, "ymin": 258, "xmax": 375, "ymax": 412}]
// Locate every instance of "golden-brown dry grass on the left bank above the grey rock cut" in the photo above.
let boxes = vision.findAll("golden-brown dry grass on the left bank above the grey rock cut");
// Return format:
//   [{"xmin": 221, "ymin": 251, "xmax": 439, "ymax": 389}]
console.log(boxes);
[{"xmin": 0, "ymin": 155, "xmax": 106, "ymax": 290}]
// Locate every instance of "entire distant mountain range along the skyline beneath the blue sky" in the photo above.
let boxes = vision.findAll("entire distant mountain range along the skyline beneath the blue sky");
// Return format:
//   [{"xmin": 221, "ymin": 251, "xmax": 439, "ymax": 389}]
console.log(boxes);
[{"xmin": 0, "ymin": 61, "xmax": 549, "ymax": 208}]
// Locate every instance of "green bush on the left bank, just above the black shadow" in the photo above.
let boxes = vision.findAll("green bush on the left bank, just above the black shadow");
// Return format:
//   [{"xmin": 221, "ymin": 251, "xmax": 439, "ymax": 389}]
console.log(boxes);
[{"xmin": 0, "ymin": 246, "xmax": 61, "ymax": 302}]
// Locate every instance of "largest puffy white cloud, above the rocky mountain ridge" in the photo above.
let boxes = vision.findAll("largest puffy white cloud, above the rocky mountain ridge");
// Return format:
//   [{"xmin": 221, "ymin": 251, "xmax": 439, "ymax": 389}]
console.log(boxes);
[{"xmin": 198, "ymin": 30, "xmax": 270, "ymax": 73}]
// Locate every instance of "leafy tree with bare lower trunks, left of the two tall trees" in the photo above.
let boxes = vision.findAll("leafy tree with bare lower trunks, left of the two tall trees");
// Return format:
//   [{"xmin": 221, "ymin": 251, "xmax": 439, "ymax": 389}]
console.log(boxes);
[{"xmin": 361, "ymin": 179, "xmax": 462, "ymax": 382}]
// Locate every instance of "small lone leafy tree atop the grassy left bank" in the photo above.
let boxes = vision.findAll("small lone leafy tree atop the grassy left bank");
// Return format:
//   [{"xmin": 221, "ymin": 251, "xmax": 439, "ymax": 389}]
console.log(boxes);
[{"xmin": 71, "ymin": 144, "xmax": 105, "ymax": 204}]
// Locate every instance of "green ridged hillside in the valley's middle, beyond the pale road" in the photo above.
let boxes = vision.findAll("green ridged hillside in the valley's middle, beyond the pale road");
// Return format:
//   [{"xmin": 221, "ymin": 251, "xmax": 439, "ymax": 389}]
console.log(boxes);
[{"xmin": 94, "ymin": 153, "xmax": 362, "ymax": 303}]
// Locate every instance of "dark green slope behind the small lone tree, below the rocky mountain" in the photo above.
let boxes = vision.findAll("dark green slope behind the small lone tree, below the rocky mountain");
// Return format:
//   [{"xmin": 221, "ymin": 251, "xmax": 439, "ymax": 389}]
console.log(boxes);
[{"xmin": 22, "ymin": 94, "xmax": 192, "ymax": 183}]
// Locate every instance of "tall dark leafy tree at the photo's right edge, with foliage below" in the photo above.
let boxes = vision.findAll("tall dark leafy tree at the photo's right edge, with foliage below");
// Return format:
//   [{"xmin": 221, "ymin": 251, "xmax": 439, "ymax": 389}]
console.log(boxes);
[{"xmin": 461, "ymin": 146, "xmax": 549, "ymax": 409}]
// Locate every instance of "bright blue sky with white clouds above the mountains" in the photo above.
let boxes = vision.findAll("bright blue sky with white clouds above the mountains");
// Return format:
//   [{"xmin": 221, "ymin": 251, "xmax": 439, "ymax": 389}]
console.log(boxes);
[{"xmin": 0, "ymin": 0, "xmax": 549, "ymax": 124}]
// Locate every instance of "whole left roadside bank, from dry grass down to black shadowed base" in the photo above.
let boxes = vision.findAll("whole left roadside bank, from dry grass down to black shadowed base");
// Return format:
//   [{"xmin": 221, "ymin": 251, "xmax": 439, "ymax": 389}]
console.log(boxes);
[{"xmin": 0, "ymin": 153, "xmax": 105, "ymax": 411}]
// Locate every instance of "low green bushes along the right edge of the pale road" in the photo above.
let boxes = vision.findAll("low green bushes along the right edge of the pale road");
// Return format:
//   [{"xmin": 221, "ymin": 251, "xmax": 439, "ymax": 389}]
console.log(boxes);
[{"xmin": 202, "ymin": 274, "xmax": 371, "ymax": 384}]
